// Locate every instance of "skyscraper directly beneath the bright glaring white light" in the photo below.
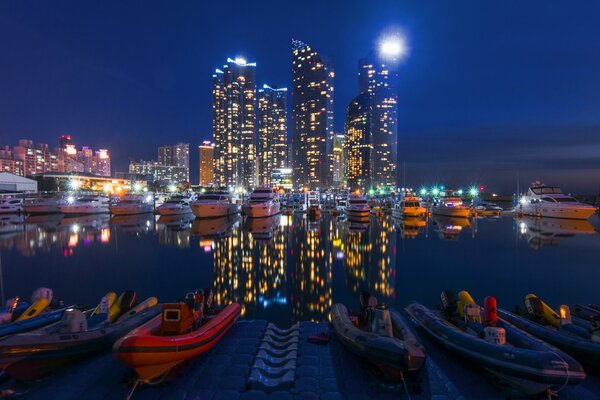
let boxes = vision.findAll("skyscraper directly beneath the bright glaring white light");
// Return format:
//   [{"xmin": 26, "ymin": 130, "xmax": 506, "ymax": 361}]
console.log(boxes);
[{"xmin": 358, "ymin": 51, "xmax": 398, "ymax": 188}]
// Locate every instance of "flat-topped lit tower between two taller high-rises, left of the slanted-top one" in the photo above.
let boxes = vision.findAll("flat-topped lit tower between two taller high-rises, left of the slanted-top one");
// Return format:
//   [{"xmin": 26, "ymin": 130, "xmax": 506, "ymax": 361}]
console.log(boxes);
[{"xmin": 257, "ymin": 85, "xmax": 288, "ymax": 185}]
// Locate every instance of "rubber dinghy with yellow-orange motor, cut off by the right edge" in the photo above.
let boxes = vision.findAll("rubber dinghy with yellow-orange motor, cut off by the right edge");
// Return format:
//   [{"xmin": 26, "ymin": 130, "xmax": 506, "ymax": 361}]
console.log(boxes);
[{"xmin": 498, "ymin": 294, "xmax": 600, "ymax": 368}]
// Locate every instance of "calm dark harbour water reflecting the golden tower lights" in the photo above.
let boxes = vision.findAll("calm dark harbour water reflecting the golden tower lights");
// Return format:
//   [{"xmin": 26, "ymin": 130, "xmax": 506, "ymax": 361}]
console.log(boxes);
[{"xmin": 0, "ymin": 214, "xmax": 600, "ymax": 326}]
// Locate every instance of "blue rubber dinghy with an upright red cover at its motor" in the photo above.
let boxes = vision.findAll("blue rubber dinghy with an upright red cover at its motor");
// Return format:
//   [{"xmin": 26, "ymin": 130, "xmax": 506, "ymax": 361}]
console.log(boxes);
[{"xmin": 406, "ymin": 291, "xmax": 586, "ymax": 394}]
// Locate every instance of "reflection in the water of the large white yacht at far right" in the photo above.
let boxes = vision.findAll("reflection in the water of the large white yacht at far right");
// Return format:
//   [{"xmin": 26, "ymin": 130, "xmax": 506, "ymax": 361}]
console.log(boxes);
[{"xmin": 515, "ymin": 218, "xmax": 596, "ymax": 249}]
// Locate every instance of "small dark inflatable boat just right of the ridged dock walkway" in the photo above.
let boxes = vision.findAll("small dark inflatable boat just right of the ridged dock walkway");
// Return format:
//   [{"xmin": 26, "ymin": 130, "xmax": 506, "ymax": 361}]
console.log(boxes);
[{"xmin": 330, "ymin": 293, "xmax": 425, "ymax": 377}]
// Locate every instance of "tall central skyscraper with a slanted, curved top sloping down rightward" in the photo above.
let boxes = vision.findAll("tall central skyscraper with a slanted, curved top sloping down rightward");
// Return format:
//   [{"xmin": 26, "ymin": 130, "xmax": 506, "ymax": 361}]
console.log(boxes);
[{"xmin": 292, "ymin": 39, "xmax": 334, "ymax": 189}]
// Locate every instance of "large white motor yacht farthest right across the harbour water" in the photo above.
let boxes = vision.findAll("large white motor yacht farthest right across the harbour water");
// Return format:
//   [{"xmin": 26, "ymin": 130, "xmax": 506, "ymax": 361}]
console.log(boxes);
[{"xmin": 515, "ymin": 182, "xmax": 597, "ymax": 220}]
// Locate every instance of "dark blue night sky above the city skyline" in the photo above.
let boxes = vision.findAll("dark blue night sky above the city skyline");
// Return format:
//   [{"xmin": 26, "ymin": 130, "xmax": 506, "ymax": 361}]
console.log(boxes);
[{"xmin": 0, "ymin": 0, "xmax": 600, "ymax": 192}]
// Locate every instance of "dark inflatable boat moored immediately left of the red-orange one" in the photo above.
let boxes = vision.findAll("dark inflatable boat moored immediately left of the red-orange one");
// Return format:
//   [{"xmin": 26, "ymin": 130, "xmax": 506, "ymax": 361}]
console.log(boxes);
[{"xmin": 0, "ymin": 291, "xmax": 160, "ymax": 382}]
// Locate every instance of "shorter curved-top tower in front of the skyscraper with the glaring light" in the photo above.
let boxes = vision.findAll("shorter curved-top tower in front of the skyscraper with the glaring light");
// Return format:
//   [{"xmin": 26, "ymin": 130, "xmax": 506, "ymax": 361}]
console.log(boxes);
[{"xmin": 345, "ymin": 92, "xmax": 373, "ymax": 191}]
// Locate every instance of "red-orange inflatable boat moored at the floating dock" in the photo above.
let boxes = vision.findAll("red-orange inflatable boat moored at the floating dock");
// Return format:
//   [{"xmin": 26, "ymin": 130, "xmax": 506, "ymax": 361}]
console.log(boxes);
[{"xmin": 113, "ymin": 291, "xmax": 242, "ymax": 388}]
